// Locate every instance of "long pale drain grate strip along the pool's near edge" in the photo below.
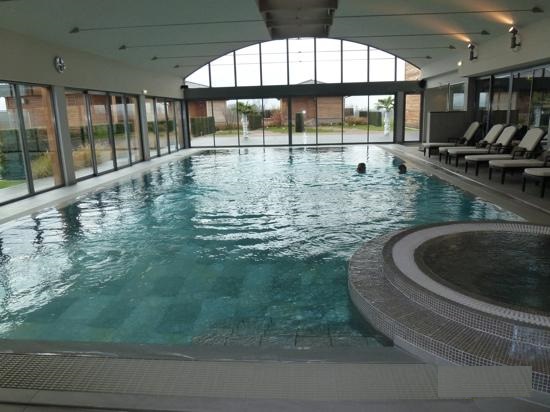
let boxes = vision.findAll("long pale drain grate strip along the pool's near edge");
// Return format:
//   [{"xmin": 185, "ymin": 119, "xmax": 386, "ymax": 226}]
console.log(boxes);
[{"xmin": 0, "ymin": 354, "xmax": 437, "ymax": 400}]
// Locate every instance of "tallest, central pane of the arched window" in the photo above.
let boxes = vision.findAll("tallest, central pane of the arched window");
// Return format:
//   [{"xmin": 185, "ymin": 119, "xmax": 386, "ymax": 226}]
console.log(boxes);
[{"xmin": 288, "ymin": 39, "xmax": 315, "ymax": 84}]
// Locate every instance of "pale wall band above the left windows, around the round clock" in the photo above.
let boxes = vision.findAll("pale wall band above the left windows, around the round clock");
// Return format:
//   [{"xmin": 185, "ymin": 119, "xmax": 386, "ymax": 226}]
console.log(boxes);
[{"xmin": 0, "ymin": 29, "xmax": 183, "ymax": 98}]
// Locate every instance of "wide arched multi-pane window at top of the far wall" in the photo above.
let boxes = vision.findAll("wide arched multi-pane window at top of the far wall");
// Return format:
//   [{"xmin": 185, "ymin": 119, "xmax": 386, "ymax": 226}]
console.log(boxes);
[{"xmin": 185, "ymin": 38, "xmax": 420, "ymax": 88}]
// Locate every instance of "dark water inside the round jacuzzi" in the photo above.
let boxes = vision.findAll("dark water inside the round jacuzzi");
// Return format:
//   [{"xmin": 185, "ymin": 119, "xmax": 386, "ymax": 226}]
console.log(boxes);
[{"xmin": 415, "ymin": 231, "xmax": 550, "ymax": 315}]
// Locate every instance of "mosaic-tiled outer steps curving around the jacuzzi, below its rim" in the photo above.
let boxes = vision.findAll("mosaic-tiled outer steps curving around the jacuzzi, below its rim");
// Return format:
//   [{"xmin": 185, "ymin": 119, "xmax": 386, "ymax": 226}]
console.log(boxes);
[{"xmin": 348, "ymin": 227, "xmax": 550, "ymax": 393}]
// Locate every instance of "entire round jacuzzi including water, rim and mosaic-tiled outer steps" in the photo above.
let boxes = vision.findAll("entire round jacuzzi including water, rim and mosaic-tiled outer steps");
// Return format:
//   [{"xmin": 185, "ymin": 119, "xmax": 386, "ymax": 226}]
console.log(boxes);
[{"xmin": 348, "ymin": 221, "xmax": 550, "ymax": 393}]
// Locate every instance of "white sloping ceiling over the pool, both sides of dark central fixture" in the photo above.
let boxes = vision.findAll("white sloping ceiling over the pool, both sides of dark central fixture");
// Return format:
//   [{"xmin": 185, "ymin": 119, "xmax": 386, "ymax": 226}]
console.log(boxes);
[{"xmin": 0, "ymin": 0, "xmax": 550, "ymax": 77}]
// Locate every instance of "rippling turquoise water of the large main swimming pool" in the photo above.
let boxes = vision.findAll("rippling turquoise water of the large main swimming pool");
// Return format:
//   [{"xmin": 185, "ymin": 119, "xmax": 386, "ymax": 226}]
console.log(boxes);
[{"xmin": 0, "ymin": 146, "xmax": 518, "ymax": 346}]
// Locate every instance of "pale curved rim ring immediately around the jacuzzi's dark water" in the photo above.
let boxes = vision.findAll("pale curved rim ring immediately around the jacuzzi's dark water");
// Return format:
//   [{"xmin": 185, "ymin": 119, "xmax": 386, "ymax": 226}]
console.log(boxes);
[{"xmin": 390, "ymin": 221, "xmax": 550, "ymax": 328}]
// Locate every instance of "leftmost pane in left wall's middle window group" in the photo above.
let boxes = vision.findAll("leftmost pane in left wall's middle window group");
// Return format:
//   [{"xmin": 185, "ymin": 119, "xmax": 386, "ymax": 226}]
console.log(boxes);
[{"xmin": 65, "ymin": 90, "xmax": 94, "ymax": 179}]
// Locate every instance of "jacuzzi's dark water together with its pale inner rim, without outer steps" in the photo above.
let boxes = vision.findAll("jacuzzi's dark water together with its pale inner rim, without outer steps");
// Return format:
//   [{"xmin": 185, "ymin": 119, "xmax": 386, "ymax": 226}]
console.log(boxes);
[{"xmin": 392, "ymin": 222, "xmax": 550, "ymax": 327}]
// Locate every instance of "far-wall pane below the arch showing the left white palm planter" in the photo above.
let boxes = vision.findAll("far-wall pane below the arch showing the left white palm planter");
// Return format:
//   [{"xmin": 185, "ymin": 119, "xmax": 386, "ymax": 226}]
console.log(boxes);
[{"xmin": 237, "ymin": 99, "xmax": 264, "ymax": 146}]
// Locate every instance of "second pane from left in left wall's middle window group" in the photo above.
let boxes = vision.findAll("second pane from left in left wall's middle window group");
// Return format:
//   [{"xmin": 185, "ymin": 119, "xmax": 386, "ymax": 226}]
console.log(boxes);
[{"xmin": 88, "ymin": 93, "xmax": 115, "ymax": 173}]
